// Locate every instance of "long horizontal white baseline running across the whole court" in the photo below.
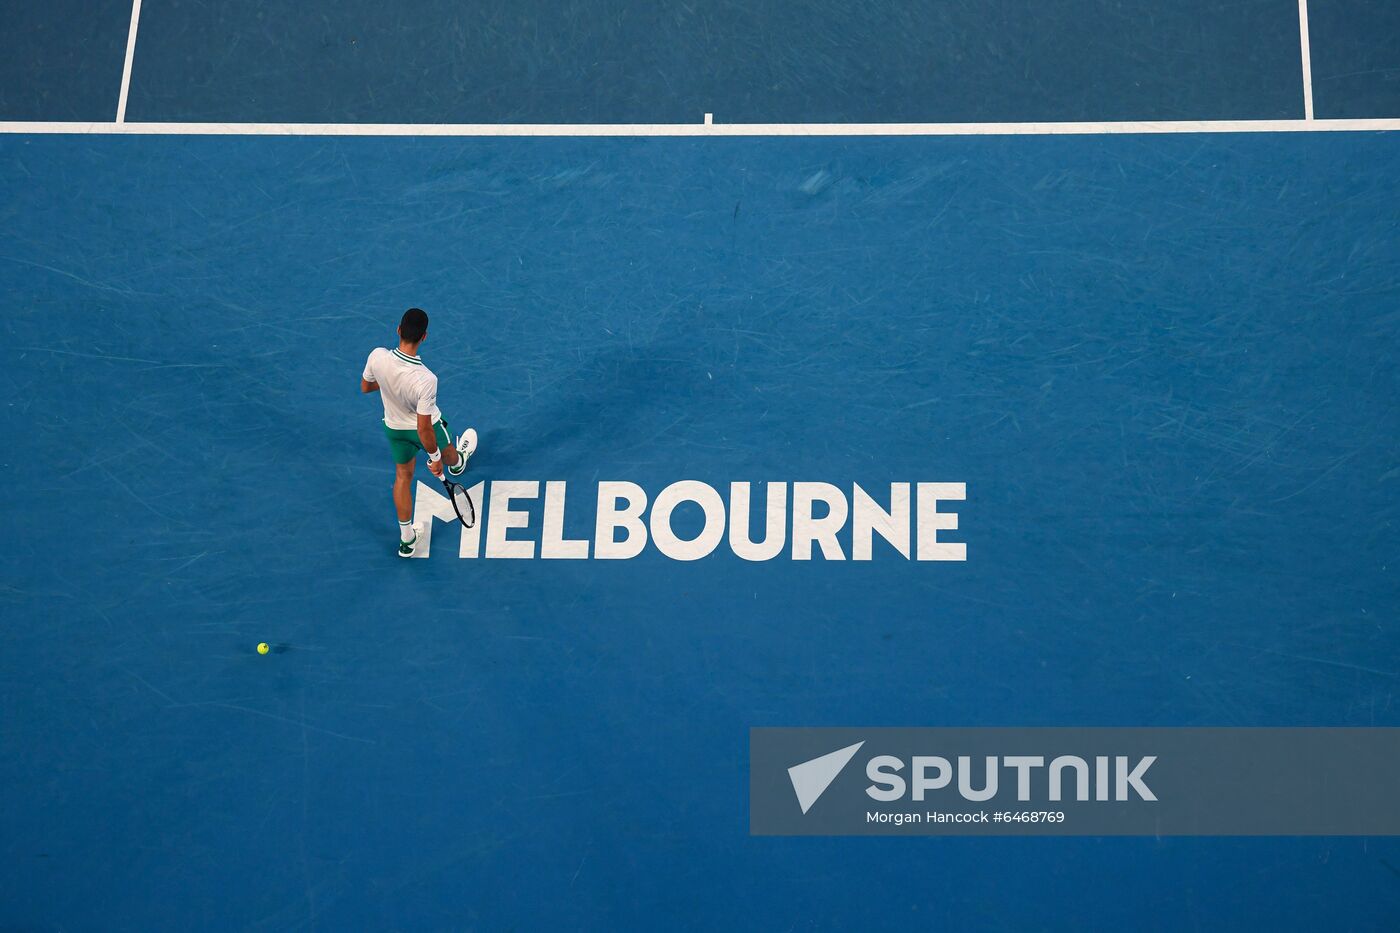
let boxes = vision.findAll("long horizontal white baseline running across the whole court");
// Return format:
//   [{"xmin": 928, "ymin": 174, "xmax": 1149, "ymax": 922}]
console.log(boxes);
[{"xmin": 0, "ymin": 118, "xmax": 1400, "ymax": 136}]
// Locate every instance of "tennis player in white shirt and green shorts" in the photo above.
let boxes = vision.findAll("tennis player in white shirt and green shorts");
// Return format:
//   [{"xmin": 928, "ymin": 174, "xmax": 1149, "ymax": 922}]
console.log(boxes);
[{"xmin": 360, "ymin": 308, "xmax": 476, "ymax": 558}]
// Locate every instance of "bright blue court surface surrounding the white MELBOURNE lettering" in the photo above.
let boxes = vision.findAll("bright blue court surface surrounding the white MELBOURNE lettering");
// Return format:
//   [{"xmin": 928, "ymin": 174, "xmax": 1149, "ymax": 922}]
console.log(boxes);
[{"xmin": 0, "ymin": 133, "xmax": 1400, "ymax": 930}]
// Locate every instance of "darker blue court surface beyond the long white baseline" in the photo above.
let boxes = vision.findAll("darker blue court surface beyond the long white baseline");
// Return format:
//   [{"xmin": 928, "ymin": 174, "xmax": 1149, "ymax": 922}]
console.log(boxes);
[{"xmin": 8, "ymin": 0, "xmax": 1400, "ymax": 123}]
